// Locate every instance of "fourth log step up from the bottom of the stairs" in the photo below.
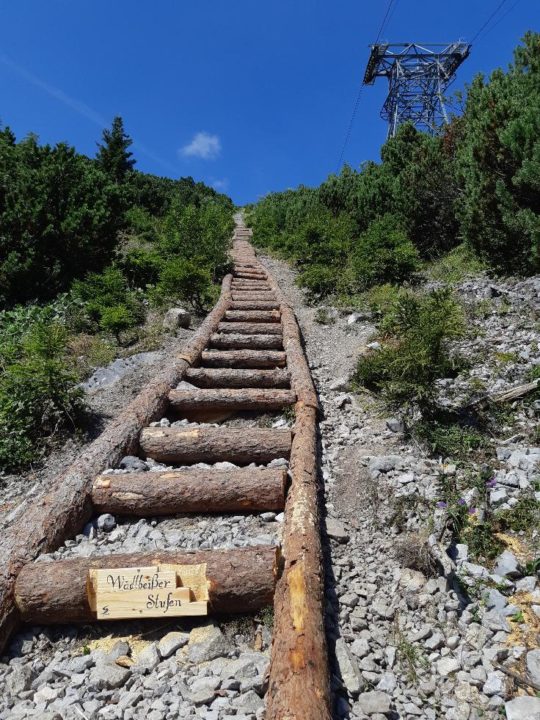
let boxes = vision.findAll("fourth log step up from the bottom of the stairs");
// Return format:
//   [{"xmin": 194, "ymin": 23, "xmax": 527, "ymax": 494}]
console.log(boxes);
[{"xmin": 169, "ymin": 388, "xmax": 296, "ymax": 414}]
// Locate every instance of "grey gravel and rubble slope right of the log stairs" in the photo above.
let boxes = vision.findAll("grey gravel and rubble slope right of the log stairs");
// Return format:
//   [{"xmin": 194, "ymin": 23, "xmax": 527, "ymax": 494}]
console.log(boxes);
[{"xmin": 264, "ymin": 258, "xmax": 540, "ymax": 720}]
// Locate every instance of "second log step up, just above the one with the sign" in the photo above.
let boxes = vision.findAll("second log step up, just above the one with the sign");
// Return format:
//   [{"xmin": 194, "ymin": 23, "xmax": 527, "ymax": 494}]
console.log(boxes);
[{"xmin": 92, "ymin": 468, "xmax": 287, "ymax": 517}]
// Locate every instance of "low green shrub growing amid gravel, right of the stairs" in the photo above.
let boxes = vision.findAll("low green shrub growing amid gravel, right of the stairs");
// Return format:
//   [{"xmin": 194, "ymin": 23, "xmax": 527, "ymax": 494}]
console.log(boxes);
[{"xmin": 354, "ymin": 290, "xmax": 464, "ymax": 410}]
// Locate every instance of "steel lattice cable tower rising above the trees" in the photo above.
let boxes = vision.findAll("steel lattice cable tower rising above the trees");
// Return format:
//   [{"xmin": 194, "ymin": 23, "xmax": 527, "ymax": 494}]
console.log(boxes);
[{"xmin": 364, "ymin": 41, "xmax": 471, "ymax": 137}]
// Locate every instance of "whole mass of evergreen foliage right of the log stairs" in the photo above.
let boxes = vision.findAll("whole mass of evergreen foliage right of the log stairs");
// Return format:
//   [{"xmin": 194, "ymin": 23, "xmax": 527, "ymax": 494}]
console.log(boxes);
[{"xmin": 250, "ymin": 32, "xmax": 540, "ymax": 297}]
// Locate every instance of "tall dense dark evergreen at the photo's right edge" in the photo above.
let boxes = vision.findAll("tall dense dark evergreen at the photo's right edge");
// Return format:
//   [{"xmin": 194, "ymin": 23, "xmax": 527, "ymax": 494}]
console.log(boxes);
[{"xmin": 458, "ymin": 32, "xmax": 540, "ymax": 272}]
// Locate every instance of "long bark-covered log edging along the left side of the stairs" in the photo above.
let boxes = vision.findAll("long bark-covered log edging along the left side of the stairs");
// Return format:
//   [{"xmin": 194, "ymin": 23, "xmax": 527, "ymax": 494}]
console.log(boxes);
[{"xmin": 0, "ymin": 275, "xmax": 232, "ymax": 654}]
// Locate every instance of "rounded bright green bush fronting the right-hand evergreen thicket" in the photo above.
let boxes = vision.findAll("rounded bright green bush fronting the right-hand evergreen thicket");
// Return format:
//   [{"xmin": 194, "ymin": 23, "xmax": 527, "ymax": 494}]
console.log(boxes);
[{"xmin": 350, "ymin": 214, "xmax": 419, "ymax": 289}]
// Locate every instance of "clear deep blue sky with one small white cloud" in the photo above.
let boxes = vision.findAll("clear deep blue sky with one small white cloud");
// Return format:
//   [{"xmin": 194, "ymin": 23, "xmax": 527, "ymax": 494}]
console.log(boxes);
[{"xmin": 0, "ymin": 0, "xmax": 540, "ymax": 204}]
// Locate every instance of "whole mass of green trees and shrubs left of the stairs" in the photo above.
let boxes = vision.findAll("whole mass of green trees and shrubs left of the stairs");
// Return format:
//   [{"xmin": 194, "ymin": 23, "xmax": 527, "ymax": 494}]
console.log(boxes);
[{"xmin": 0, "ymin": 118, "xmax": 233, "ymax": 470}]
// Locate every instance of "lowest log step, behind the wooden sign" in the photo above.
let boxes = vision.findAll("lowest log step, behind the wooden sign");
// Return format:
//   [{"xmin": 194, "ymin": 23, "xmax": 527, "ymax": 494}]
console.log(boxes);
[{"xmin": 15, "ymin": 547, "xmax": 277, "ymax": 625}]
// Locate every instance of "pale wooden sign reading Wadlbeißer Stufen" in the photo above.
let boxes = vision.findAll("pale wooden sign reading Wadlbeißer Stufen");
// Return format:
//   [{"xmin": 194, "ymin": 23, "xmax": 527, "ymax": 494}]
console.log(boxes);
[{"xmin": 87, "ymin": 564, "xmax": 208, "ymax": 620}]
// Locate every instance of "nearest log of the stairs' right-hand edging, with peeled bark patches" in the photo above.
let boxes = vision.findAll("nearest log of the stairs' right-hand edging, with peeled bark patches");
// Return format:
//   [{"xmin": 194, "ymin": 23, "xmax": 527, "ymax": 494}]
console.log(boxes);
[{"xmin": 266, "ymin": 403, "xmax": 332, "ymax": 720}]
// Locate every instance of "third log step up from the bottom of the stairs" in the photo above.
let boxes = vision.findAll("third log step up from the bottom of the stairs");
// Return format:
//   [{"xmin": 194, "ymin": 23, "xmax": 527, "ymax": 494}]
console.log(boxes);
[{"xmin": 140, "ymin": 425, "xmax": 291, "ymax": 465}]
